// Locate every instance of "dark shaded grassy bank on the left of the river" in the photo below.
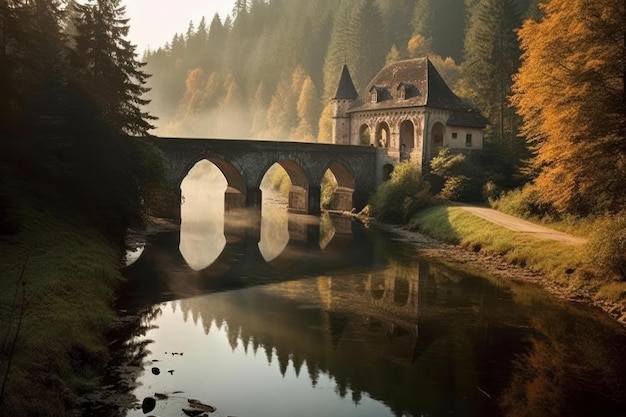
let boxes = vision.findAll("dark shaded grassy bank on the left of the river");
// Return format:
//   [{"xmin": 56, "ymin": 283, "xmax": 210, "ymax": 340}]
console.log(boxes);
[{"xmin": 0, "ymin": 208, "xmax": 119, "ymax": 416}]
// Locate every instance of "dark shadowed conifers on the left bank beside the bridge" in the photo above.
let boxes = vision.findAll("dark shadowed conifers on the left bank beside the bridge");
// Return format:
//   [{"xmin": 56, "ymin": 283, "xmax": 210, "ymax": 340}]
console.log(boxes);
[{"xmin": 0, "ymin": 0, "xmax": 160, "ymax": 239}]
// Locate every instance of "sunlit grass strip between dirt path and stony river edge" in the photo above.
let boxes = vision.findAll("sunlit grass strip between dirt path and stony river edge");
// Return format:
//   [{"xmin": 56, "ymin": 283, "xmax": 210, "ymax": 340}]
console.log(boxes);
[{"xmin": 409, "ymin": 205, "xmax": 626, "ymax": 311}]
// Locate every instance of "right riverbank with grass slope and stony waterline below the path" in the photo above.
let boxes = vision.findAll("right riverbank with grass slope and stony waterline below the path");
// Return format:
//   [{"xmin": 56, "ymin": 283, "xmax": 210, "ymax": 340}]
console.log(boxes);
[{"xmin": 366, "ymin": 205, "xmax": 626, "ymax": 326}]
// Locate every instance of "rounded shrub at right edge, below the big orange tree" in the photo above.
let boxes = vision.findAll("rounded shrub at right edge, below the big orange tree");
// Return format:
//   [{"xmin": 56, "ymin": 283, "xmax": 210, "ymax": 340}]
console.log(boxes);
[{"xmin": 586, "ymin": 211, "xmax": 626, "ymax": 281}]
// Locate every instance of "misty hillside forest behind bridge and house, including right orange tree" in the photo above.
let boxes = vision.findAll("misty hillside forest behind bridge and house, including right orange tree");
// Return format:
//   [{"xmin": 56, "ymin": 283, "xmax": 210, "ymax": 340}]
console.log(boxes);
[{"xmin": 143, "ymin": 0, "xmax": 626, "ymax": 216}]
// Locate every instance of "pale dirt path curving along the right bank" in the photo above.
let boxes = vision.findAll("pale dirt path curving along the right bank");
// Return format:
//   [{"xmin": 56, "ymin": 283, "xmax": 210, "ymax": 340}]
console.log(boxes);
[{"xmin": 450, "ymin": 204, "xmax": 587, "ymax": 245}]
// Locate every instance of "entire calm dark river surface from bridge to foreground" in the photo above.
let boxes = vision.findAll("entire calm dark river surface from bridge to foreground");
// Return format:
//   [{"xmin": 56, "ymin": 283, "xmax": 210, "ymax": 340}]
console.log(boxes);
[{"xmin": 91, "ymin": 174, "xmax": 626, "ymax": 417}]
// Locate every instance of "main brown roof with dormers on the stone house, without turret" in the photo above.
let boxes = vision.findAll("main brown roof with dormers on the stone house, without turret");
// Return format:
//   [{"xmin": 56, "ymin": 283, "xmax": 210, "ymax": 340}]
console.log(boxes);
[{"xmin": 342, "ymin": 58, "xmax": 488, "ymax": 127}]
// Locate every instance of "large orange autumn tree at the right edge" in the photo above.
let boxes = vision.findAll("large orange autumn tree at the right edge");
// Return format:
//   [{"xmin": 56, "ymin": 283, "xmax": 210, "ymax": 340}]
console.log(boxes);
[{"xmin": 512, "ymin": 0, "xmax": 626, "ymax": 213}]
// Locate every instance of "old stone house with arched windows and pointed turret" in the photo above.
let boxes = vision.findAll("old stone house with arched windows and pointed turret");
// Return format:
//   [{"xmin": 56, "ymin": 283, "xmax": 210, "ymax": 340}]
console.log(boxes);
[{"xmin": 332, "ymin": 58, "xmax": 488, "ymax": 171}]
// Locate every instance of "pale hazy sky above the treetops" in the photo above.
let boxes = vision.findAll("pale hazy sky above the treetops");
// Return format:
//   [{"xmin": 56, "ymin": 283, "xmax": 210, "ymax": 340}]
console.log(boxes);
[{"xmin": 124, "ymin": 0, "xmax": 235, "ymax": 52}]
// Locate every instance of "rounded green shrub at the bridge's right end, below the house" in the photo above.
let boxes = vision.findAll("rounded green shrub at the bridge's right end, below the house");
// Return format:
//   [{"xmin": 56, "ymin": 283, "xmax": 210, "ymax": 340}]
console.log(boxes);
[{"xmin": 370, "ymin": 161, "xmax": 432, "ymax": 223}]
